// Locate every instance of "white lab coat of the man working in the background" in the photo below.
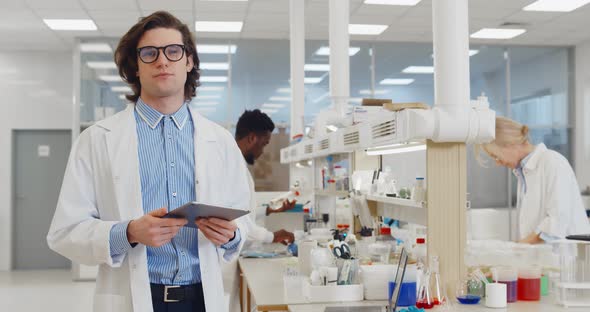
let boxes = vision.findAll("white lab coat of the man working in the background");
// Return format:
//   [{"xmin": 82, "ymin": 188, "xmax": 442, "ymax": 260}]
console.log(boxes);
[{"xmin": 222, "ymin": 171, "xmax": 274, "ymax": 312}]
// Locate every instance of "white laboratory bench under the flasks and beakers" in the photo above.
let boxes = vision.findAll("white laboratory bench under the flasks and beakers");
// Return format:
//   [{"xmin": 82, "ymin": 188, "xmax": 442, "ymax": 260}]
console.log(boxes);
[{"xmin": 239, "ymin": 257, "xmax": 590, "ymax": 312}]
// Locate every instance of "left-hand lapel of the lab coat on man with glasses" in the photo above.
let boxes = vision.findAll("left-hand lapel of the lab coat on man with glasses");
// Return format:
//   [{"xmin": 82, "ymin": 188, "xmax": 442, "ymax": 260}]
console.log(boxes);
[{"xmin": 105, "ymin": 105, "xmax": 144, "ymax": 220}]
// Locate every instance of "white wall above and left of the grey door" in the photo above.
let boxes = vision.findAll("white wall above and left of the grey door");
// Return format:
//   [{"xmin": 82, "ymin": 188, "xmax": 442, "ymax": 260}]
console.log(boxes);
[{"xmin": 0, "ymin": 52, "xmax": 72, "ymax": 271}]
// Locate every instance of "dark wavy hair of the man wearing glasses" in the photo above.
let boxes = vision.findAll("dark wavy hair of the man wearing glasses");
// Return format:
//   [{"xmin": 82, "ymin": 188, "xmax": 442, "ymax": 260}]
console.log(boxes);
[{"xmin": 115, "ymin": 11, "xmax": 200, "ymax": 103}]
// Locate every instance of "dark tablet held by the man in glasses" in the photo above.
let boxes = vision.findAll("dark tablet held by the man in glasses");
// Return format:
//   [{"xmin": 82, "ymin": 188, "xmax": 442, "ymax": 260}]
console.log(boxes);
[{"xmin": 164, "ymin": 202, "xmax": 250, "ymax": 227}]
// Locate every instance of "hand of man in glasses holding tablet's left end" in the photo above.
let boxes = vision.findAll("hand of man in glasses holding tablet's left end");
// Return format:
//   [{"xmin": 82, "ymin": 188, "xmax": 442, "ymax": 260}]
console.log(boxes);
[{"xmin": 127, "ymin": 207, "xmax": 187, "ymax": 247}]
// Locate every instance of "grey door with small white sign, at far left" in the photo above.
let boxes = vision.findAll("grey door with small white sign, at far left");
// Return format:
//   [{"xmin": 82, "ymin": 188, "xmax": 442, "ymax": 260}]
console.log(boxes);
[{"xmin": 12, "ymin": 130, "xmax": 71, "ymax": 270}]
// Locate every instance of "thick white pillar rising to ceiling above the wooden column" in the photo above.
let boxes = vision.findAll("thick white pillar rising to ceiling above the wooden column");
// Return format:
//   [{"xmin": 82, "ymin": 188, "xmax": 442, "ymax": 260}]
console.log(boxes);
[{"xmin": 432, "ymin": 0, "xmax": 470, "ymax": 111}]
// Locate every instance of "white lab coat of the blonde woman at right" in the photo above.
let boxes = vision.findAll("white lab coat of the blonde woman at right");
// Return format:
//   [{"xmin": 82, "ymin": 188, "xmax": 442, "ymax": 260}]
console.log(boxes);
[{"xmin": 515, "ymin": 143, "xmax": 590, "ymax": 239}]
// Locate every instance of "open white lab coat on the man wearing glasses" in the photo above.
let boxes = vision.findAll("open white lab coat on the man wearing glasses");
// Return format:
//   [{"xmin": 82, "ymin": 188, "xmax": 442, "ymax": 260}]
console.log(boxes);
[{"xmin": 47, "ymin": 105, "xmax": 253, "ymax": 312}]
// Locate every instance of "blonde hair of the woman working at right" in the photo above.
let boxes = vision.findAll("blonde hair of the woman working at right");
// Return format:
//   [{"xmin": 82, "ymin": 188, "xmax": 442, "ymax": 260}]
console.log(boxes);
[{"xmin": 475, "ymin": 117, "xmax": 529, "ymax": 165}]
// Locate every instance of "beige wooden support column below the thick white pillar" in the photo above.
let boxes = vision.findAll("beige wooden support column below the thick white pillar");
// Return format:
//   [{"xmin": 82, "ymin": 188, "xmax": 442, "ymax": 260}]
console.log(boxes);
[{"xmin": 426, "ymin": 141, "xmax": 467, "ymax": 288}]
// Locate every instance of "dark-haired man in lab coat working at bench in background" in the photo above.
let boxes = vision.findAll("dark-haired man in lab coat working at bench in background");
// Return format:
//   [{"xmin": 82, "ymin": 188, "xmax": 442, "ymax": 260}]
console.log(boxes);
[{"xmin": 223, "ymin": 109, "xmax": 295, "ymax": 311}]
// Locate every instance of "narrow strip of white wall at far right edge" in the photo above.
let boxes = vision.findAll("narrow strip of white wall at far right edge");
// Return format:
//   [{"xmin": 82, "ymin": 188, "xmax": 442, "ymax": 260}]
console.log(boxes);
[{"xmin": 574, "ymin": 41, "xmax": 590, "ymax": 188}]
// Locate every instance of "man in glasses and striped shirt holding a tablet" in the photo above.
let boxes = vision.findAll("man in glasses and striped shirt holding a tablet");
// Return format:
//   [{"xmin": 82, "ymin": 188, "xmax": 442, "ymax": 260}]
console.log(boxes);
[{"xmin": 47, "ymin": 11, "xmax": 252, "ymax": 312}]
